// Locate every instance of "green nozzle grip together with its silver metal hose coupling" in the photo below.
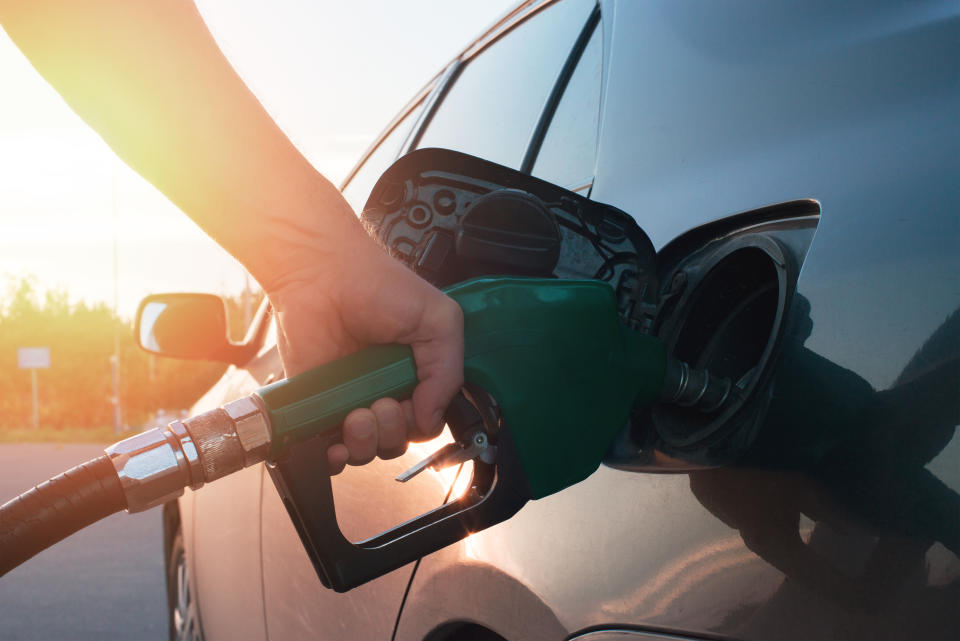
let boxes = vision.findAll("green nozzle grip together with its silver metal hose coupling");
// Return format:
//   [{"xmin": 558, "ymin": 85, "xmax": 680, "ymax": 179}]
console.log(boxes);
[{"xmin": 106, "ymin": 345, "xmax": 417, "ymax": 512}]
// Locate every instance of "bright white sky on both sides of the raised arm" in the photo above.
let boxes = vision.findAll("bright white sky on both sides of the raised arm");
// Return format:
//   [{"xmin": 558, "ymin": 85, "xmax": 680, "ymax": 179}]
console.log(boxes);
[{"xmin": 0, "ymin": 0, "xmax": 516, "ymax": 317}]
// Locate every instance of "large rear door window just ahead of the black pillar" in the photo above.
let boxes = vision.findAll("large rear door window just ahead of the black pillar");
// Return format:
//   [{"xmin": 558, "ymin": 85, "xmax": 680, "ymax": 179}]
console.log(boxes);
[{"xmin": 417, "ymin": 0, "xmax": 596, "ymax": 169}]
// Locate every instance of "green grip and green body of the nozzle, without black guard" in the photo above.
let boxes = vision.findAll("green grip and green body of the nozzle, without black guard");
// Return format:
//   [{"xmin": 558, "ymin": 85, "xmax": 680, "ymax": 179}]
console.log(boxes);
[{"xmin": 256, "ymin": 278, "xmax": 667, "ymax": 498}]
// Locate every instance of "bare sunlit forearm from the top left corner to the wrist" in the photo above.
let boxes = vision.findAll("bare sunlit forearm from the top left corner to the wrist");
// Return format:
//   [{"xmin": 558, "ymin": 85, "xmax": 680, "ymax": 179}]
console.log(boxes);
[{"xmin": 0, "ymin": 0, "xmax": 359, "ymax": 289}]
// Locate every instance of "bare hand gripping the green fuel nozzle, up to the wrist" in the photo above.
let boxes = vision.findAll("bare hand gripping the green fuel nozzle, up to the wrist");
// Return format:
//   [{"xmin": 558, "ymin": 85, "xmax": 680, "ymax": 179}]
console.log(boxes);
[{"xmin": 267, "ymin": 226, "xmax": 463, "ymax": 474}]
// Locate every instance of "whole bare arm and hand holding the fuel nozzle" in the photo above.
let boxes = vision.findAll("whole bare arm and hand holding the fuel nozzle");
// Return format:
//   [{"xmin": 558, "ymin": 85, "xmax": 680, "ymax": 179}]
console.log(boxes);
[{"xmin": 0, "ymin": 0, "xmax": 463, "ymax": 469}]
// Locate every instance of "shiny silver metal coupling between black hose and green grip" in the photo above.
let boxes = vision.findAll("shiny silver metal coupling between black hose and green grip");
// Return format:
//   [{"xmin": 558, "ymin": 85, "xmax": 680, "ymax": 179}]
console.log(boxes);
[{"xmin": 106, "ymin": 395, "xmax": 270, "ymax": 512}]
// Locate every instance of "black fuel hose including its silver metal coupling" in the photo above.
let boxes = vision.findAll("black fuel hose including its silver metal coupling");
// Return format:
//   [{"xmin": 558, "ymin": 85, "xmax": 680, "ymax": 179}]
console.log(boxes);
[{"xmin": 0, "ymin": 396, "xmax": 270, "ymax": 576}]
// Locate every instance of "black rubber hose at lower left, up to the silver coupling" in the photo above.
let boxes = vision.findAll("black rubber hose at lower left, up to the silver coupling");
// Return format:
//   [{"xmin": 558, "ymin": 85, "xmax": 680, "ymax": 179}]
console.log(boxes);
[{"xmin": 0, "ymin": 455, "xmax": 127, "ymax": 576}]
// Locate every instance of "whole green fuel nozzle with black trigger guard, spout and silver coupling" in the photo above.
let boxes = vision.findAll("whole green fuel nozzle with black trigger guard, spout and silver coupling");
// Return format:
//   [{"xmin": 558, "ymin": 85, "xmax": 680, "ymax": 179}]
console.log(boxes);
[{"xmin": 99, "ymin": 277, "xmax": 730, "ymax": 591}]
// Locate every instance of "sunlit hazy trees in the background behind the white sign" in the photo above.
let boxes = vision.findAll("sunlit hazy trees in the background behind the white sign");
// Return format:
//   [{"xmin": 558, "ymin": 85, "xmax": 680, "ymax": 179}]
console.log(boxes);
[{"xmin": 0, "ymin": 278, "xmax": 253, "ymax": 429}]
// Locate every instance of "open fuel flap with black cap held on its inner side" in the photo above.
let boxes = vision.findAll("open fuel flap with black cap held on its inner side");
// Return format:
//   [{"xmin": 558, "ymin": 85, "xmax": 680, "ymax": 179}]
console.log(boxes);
[{"xmin": 361, "ymin": 149, "xmax": 657, "ymax": 329}]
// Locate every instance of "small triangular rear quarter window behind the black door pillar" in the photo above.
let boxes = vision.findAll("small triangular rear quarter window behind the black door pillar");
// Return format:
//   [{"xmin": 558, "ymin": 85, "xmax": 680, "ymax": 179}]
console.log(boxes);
[{"xmin": 530, "ymin": 21, "xmax": 603, "ymax": 188}]
